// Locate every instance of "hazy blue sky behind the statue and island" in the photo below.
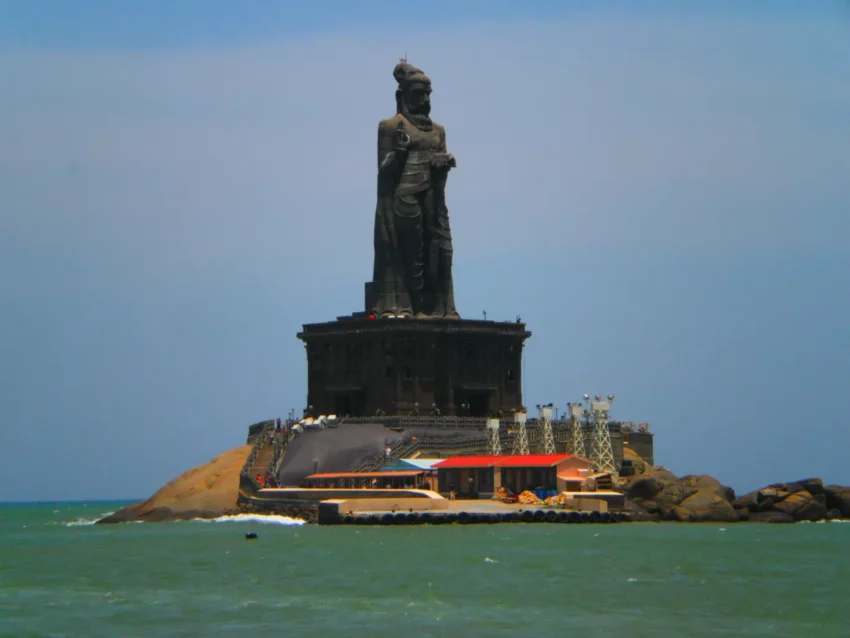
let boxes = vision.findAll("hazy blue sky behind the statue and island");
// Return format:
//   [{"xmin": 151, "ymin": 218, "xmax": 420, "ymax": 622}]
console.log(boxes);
[{"xmin": 0, "ymin": 0, "xmax": 850, "ymax": 500}]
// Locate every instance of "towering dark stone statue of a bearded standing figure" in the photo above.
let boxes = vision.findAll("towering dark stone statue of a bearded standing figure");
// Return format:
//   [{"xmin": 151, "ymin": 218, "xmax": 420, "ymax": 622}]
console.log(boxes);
[{"xmin": 366, "ymin": 61, "xmax": 458, "ymax": 318}]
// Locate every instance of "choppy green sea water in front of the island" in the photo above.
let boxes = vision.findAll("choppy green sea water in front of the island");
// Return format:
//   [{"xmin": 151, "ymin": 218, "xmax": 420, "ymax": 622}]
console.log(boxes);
[{"xmin": 0, "ymin": 503, "xmax": 850, "ymax": 638}]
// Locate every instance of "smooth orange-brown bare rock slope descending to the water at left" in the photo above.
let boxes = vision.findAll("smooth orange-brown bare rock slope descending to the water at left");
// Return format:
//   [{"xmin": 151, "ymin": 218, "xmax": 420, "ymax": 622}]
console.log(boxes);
[{"xmin": 98, "ymin": 445, "xmax": 251, "ymax": 523}]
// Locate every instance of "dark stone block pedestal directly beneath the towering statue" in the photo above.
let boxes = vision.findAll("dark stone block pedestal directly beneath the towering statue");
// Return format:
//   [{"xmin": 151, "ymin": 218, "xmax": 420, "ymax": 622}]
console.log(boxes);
[{"xmin": 298, "ymin": 314, "xmax": 531, "ymax": 416}]
